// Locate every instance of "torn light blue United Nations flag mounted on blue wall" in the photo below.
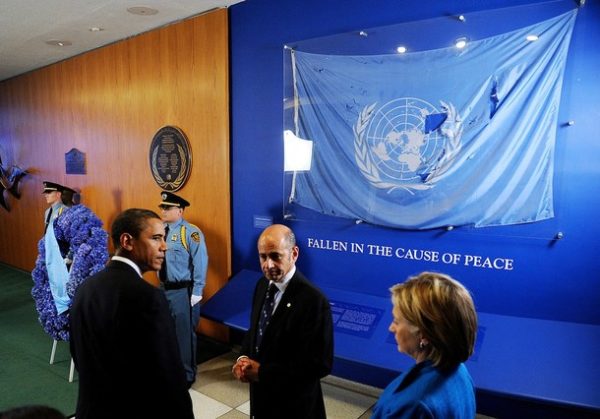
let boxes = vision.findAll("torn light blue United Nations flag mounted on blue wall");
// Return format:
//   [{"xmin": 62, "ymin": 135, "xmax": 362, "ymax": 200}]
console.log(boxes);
[{"xmin": 289, "ymin": 10, "xmax": 577, "ymax": 229}]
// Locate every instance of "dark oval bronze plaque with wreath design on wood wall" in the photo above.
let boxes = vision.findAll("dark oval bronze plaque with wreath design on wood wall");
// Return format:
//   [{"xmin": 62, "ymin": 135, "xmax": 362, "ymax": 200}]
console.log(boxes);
[{"xmin": 150, "ymin": 126, "xmax": 192, "ymax": 192}]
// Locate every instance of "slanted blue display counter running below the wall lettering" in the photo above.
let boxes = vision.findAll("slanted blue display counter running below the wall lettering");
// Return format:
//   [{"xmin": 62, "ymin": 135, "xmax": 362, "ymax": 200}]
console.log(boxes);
[{"xmin": 202, "ymin": 270, "xmax": 600, "ymax": 417}]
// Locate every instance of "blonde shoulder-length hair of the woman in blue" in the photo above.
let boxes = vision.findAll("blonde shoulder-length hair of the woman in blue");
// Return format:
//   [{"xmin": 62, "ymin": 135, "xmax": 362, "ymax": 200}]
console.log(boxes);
[{"xmin": 390, "ymin": 272, "xmax": 477, "ymax": 369}]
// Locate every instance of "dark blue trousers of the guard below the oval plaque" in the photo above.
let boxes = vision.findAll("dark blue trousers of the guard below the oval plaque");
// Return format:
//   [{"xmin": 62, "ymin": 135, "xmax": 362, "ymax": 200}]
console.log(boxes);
[{"xmin": 165, "ymin": 288, "xmax": 200, "ymax": 382}]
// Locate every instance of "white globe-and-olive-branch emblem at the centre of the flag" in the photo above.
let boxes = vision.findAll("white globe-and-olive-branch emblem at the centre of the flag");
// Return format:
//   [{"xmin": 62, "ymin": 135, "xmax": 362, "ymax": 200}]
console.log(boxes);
[{"xmin": 354, "ymin": 97, "xmax": 462, "ymax": 194}]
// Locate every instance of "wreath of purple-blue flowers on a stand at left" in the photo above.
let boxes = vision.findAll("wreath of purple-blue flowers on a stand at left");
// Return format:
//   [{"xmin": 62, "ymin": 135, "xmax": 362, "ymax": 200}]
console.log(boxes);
[{"xmin": 31, "ymin": 205, "xmax": 108, "ymax": 341}]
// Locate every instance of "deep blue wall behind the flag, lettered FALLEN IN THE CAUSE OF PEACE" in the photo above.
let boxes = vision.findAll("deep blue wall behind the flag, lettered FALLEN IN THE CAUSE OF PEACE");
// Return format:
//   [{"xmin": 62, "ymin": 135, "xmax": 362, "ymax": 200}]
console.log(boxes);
[{"xmin": 230, "ymin": 0, "xmax": 600, "ymax": 324}]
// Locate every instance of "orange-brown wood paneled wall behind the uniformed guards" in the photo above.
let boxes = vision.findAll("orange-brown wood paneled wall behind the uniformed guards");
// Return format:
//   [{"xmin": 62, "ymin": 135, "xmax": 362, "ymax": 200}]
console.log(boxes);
[{"xmin": 0, "ymin": 9, "xmax": 231, "ymax": 338}]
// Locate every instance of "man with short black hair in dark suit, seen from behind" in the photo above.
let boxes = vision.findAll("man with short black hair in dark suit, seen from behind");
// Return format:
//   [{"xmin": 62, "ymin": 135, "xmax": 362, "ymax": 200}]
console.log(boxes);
[{"xmin": 70, "ymin": 209, "xmax": 194, "ymax": 419}]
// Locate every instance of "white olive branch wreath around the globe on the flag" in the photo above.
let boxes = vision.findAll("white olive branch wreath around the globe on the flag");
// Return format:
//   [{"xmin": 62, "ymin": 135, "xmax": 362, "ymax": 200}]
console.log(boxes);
[{"xmin": 353, "ymin": 101, "xmax": 463, "ymax": 194}]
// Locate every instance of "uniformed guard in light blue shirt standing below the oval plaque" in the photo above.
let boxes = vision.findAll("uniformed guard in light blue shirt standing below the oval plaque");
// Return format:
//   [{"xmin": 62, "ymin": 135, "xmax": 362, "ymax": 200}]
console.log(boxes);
[{"xmin": 159, "ymin": 192, "xmax": 208, "ymax": 386}]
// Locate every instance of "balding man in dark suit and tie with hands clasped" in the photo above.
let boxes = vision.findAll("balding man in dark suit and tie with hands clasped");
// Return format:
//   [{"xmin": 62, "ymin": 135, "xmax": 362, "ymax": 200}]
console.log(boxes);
[{"xmin": 232, "ymin": 224, "xmax": 333, "ymax": 419}]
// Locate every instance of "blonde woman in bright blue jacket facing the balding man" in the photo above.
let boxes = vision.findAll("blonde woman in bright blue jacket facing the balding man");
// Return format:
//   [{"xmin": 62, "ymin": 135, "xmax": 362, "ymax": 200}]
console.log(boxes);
[{"xmin": 372, "ymin": 272, "xmax": 477, "ymax": 419}]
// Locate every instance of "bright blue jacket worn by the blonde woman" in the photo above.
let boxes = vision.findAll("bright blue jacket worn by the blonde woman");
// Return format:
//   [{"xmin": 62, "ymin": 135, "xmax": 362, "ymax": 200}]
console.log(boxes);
[{"xmin": 371, "ymin": 361, "xmax": 475, "ymax": 419}]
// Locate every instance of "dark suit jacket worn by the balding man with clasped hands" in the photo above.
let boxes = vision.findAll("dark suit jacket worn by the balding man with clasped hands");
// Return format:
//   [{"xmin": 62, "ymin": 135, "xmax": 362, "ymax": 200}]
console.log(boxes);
[{"xmin": 242, "ymin": 270, "xmax": 333, "ymax": 419}]
